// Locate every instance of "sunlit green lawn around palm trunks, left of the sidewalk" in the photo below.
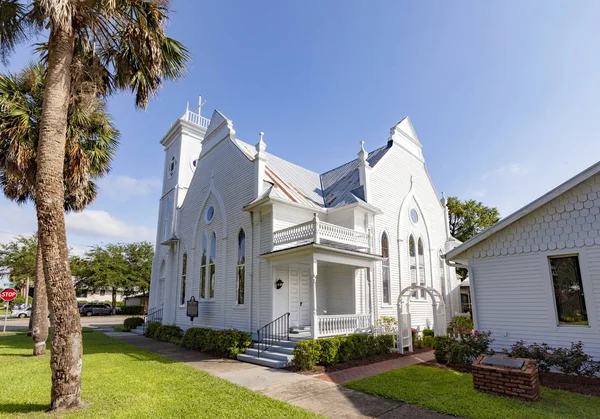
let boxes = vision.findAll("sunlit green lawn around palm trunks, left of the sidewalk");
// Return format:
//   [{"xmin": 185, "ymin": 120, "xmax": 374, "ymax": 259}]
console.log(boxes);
[{"xmin": 0, "ymin": 332, "xmax": 318, "ymax": 418}]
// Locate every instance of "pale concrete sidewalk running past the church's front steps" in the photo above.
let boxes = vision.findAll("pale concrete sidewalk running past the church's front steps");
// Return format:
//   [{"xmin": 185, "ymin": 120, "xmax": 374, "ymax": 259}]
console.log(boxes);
[{"xmin": 97, "ymin": 329, "xmax": 448, "ymax": 419}]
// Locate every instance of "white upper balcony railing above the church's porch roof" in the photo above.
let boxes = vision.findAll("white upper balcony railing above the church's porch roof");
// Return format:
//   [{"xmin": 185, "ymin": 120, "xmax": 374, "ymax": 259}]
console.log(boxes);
[{"xmin": 273, "ymin": 214, "xmax": 369, "ymax": 249}]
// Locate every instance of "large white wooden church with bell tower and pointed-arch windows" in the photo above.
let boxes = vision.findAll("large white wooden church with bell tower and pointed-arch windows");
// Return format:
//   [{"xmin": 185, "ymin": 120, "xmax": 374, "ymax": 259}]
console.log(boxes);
[{"xmin": 149, "ymin": 99, "xmax": 460, "ymax": 358}]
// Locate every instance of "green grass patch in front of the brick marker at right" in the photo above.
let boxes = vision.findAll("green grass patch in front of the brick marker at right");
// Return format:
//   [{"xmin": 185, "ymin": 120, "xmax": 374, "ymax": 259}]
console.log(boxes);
[{"xmin": 345, "ymin": 365, "xmax": 600, "ymax": 419}]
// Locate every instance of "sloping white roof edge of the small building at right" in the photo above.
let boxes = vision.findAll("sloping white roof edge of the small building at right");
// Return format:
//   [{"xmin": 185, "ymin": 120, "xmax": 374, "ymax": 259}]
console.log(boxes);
[{"xmin": 444, "ymin": 161, "xmax": 600, "ymax": 260}]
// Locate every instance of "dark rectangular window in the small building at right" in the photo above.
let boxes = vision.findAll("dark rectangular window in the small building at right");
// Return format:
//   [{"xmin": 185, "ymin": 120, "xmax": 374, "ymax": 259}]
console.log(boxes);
[{"xmin": 550, "ymin": 256, "xmax": 589, "ymax": 326}]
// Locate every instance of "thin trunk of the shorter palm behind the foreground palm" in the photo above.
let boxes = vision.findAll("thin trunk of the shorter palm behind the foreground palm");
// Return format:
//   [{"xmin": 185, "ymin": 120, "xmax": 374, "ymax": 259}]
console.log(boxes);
[{"xmin": 31, "ymin": 240, "xmax": 48, "ymax": 355}]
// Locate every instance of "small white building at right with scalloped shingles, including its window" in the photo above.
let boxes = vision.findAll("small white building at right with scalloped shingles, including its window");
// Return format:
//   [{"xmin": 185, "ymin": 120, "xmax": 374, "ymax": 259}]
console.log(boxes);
[{"xmin": 446, "ymin": 162, "xmax": 600, "ymax": 359}]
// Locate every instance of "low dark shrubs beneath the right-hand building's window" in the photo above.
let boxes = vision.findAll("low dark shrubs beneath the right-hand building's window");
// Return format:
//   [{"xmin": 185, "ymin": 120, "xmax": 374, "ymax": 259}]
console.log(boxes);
[{"xmin": 504, "ymin": 340, "xmax": 600, "ymax": 377}]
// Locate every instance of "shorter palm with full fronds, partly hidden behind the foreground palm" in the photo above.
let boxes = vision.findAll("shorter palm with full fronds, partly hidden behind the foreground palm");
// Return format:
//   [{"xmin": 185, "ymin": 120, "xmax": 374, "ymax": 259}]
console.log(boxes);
[{"xmin": 0, "ymin": 63, "xmax": 119, "ymax": 355}]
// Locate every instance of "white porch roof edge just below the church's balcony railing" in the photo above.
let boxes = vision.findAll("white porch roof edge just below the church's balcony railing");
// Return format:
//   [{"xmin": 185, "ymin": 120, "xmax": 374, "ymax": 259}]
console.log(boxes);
[{"xmin": 259, "ymin": 243, "xmax": 385, "ymax": 267}]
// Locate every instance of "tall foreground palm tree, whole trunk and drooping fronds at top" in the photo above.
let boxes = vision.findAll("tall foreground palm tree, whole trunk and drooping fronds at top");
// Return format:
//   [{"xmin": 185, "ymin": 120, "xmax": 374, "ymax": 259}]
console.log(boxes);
[{"xmin": 0, "ymin": 0, "xmax": 189, "ymax": 411}]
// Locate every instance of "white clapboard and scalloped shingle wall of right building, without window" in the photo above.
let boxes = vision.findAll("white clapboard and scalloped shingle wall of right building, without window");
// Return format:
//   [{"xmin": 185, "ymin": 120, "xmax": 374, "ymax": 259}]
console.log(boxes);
[{"xmin": 466, "ymin": 175, "xmax": 600, "ymax": 358}]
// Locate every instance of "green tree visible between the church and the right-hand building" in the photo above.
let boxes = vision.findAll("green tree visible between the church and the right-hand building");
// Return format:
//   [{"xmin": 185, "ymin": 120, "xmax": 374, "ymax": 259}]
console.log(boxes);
[{"xmin": 447, "ymin": 196, "xmax": 500, "ymax": 279}]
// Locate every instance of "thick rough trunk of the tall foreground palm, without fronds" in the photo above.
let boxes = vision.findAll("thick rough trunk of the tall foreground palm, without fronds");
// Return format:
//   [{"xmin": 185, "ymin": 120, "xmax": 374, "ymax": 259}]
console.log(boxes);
[{"xmin": 36, "ymin": 28, "xmax": 83, "ymax": 411}]
